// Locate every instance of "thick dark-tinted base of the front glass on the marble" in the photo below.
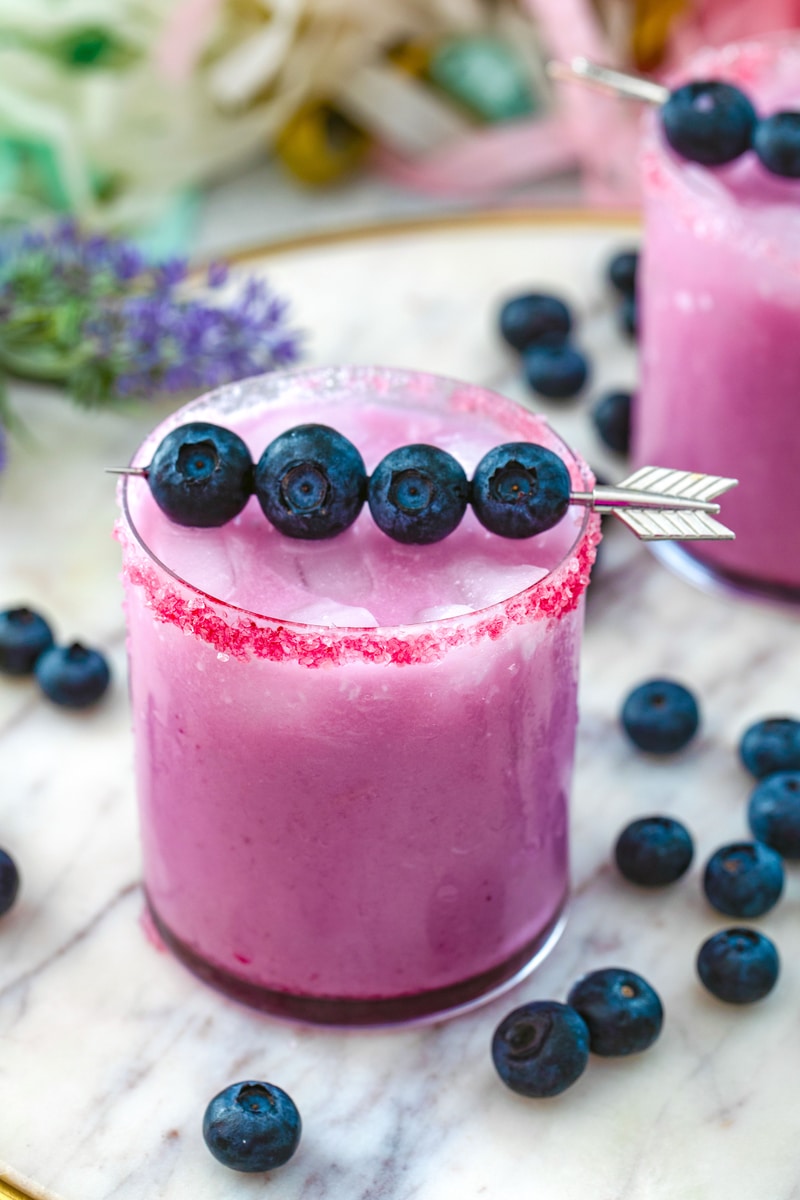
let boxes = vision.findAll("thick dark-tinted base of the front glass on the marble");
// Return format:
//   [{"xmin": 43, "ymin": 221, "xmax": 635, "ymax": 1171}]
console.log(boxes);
[{"xmin": 148, "ymin": 900, "xmax": 566, "ymax": 1027}]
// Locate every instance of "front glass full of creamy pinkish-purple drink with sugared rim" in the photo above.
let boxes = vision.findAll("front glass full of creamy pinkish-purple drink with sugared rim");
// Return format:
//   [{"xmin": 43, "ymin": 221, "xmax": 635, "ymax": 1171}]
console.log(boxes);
[{"xmin": 120, "ymin": 370, "xmax": 596, "ymax": 1020}]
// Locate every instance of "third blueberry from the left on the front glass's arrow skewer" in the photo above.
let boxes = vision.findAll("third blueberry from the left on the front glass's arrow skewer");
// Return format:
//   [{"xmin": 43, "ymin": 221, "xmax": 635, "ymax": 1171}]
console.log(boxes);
[{"xmin": 367, "ymin": 445, "xmax": 469, "ymax": 545}]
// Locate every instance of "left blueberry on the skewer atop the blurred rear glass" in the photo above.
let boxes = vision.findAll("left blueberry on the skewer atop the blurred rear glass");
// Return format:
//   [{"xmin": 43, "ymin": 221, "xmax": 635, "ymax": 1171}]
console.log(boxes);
[{"xmin": 661, "ymin": 80, "xmax": 757, "ymax": 167}]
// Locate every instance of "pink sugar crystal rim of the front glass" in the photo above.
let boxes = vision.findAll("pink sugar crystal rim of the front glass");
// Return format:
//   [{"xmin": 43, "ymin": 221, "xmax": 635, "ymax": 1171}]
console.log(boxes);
[{"xmin": 114, "ymin": 367, "xmax": 602, "ymax": 667}]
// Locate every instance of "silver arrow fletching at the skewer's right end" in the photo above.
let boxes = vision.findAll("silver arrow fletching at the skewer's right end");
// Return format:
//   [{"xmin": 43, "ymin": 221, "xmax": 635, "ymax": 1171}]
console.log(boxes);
[{"xmin": 570, "ymin": 467, "xmax": 739, "ymax": 541}]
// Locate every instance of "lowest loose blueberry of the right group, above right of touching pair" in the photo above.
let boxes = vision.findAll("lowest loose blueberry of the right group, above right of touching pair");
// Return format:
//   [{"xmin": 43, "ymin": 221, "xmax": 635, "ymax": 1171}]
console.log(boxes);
[{"xmin": 697, "ymin": 929, "xmax": 781, "ymax": 1004}]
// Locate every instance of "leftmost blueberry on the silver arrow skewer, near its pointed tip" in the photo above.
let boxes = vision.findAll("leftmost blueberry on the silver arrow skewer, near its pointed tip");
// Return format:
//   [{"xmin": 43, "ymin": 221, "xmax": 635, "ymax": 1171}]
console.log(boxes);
[{"xmin": 148, "ymin": 421, "xmax": 253, "ymax": 529}]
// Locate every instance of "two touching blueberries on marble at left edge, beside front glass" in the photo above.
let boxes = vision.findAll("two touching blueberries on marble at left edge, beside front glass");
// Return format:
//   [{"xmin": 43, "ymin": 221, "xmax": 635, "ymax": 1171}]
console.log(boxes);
[{"xmin": 0, "ymin": 606, "xmax": 112, "ymax": 708}]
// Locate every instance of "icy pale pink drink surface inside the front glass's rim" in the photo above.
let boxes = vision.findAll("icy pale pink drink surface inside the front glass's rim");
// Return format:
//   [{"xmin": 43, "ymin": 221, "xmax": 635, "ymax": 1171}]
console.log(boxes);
[{"xmin": 130, "ymin": 402, "xmax": 583, "ymax": 626}]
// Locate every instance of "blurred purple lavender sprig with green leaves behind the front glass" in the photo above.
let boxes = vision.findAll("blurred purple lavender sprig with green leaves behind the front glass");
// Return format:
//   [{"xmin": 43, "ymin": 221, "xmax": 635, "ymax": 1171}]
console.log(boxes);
[{"xmin": 0, "ymin": 223, "xmax": 300, "ymax": 424}]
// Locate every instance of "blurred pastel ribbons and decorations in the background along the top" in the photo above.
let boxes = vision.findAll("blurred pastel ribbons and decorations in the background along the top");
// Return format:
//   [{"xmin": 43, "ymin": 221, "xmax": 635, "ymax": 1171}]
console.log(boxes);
[{"xmin": 0, "ymin": 0, "xmax": 800, "ymax": 253}]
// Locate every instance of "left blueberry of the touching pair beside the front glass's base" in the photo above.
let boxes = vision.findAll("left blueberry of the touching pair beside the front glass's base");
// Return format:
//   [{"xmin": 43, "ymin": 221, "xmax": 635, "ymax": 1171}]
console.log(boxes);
[{"xmin": 492, "ymin": 1000, "xmax": 589, "ymax": 1097}]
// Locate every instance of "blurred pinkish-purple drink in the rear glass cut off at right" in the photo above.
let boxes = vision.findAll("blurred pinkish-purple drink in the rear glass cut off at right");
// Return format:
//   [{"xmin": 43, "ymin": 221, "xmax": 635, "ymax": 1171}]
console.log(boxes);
[{"xmin": 633, "ymin": 37, "xmax": 800, "ymax": 590}]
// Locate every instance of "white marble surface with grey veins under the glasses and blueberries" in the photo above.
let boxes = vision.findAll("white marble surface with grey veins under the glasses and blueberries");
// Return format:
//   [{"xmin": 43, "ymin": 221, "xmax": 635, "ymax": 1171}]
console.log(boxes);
[{"xmin": 0, "ymin": 213, "xmax": 800, "ymax": 1200}]
